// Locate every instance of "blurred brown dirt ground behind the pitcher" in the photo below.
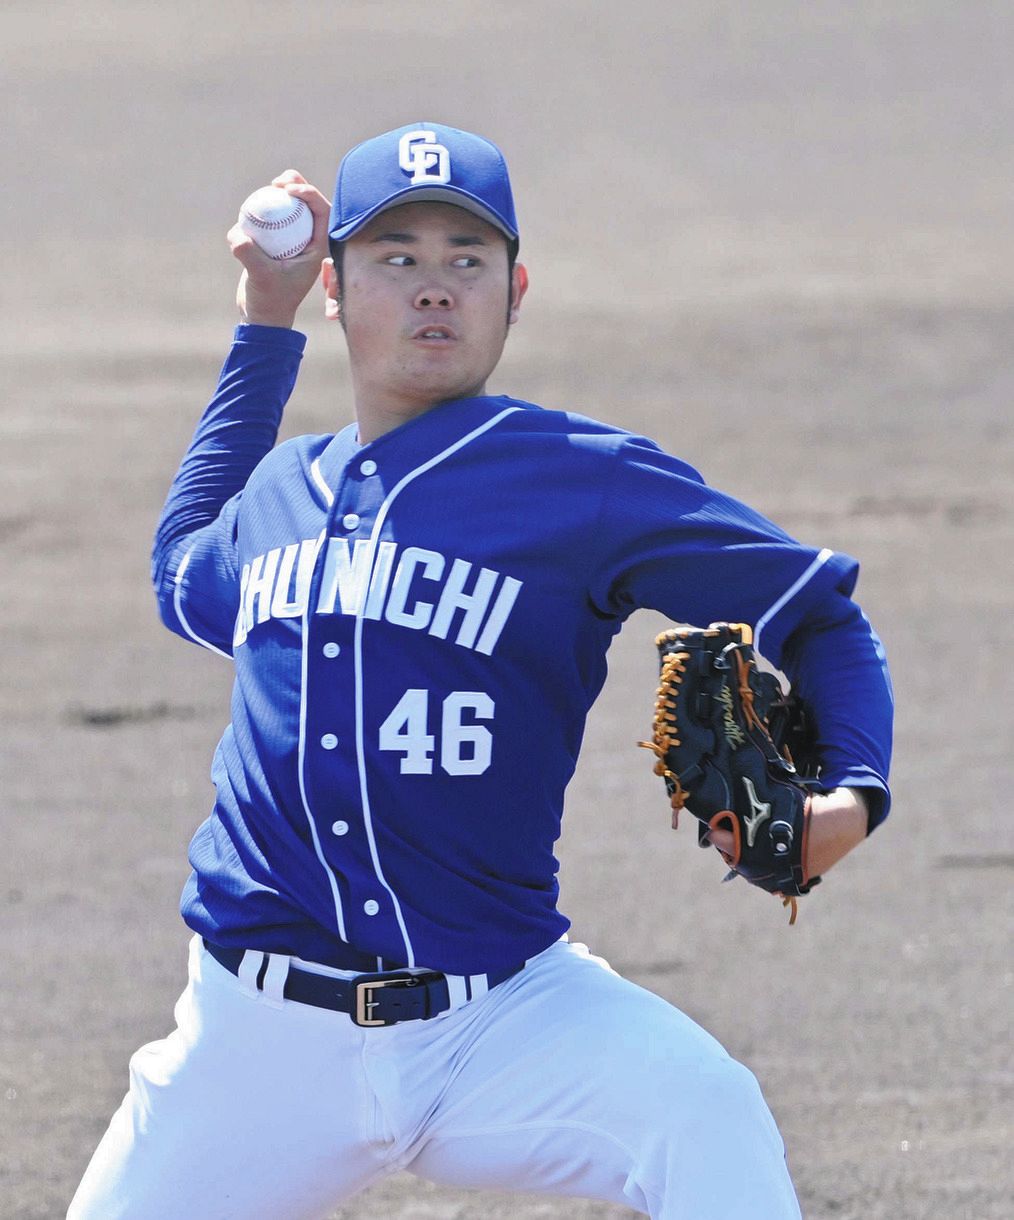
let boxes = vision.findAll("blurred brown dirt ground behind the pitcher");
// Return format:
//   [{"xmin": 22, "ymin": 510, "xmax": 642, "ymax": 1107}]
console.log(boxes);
[{"xmin": 0, "ymin": 0, "xmax": 1014, "ymax": 1220}]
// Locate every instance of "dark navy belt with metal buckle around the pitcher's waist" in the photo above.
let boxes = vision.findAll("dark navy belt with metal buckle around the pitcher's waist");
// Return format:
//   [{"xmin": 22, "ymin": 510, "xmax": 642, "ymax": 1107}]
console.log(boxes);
[{"xmin": 204, "ymin": 941, "xmax": 525, "ymax": 1026}]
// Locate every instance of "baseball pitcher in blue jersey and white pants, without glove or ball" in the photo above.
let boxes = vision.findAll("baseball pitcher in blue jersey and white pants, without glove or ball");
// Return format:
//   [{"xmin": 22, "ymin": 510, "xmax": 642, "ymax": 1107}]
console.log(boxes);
[{"xmin": 70, "ymin": 123, "xmax": 891, "ymax": 1220}]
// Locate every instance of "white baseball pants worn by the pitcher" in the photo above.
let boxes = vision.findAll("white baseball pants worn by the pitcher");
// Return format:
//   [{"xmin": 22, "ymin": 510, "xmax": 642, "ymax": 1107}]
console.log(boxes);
[{"xmin": 68, "ymin": 938, "xmax": 799, "ymax": 1220}]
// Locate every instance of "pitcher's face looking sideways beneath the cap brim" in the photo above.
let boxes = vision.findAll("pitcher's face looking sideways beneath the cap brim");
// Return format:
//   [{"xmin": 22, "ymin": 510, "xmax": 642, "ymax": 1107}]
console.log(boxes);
[{"xmin": 326, "ymin": 203, "xmax": 527, "ymax": 427}]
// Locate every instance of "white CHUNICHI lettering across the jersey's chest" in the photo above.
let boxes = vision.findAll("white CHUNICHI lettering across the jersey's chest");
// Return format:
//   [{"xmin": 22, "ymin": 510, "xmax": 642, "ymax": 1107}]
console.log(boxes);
[{"xmin": 233, "ymin": 538, "xmax": 523, "ymax": 655}]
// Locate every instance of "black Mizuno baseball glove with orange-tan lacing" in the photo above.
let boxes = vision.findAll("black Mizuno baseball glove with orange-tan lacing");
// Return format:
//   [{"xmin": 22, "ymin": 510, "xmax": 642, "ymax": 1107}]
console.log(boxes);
[{"xmin": 639, "ymin": 622, "xmax": 820, "ymax": 924}]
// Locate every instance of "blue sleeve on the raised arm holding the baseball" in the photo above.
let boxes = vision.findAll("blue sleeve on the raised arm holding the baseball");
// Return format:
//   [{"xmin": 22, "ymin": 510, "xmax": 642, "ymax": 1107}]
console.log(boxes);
[{"xmin": 151, "ymin": 325, "xmax": 306, "ymax": 656}]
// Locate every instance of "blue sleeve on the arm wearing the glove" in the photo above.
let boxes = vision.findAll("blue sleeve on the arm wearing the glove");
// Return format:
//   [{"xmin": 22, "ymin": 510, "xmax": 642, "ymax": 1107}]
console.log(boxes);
[{"xmin": 589, "ymin": 437, "xmax": 893, "ymax": 828}]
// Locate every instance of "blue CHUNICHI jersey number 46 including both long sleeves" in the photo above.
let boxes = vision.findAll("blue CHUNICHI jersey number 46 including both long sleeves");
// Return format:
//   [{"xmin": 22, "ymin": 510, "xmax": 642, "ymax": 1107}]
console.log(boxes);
[{"xmin": 153, "ymin": 326, "xmax": 892, "ymax": 975}]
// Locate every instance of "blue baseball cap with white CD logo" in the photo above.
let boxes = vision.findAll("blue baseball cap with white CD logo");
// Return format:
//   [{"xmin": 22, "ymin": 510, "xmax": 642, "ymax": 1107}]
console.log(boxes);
[{"xmin": 327, "ymin": 123, "xmax": 517, "ymax": 245}]
